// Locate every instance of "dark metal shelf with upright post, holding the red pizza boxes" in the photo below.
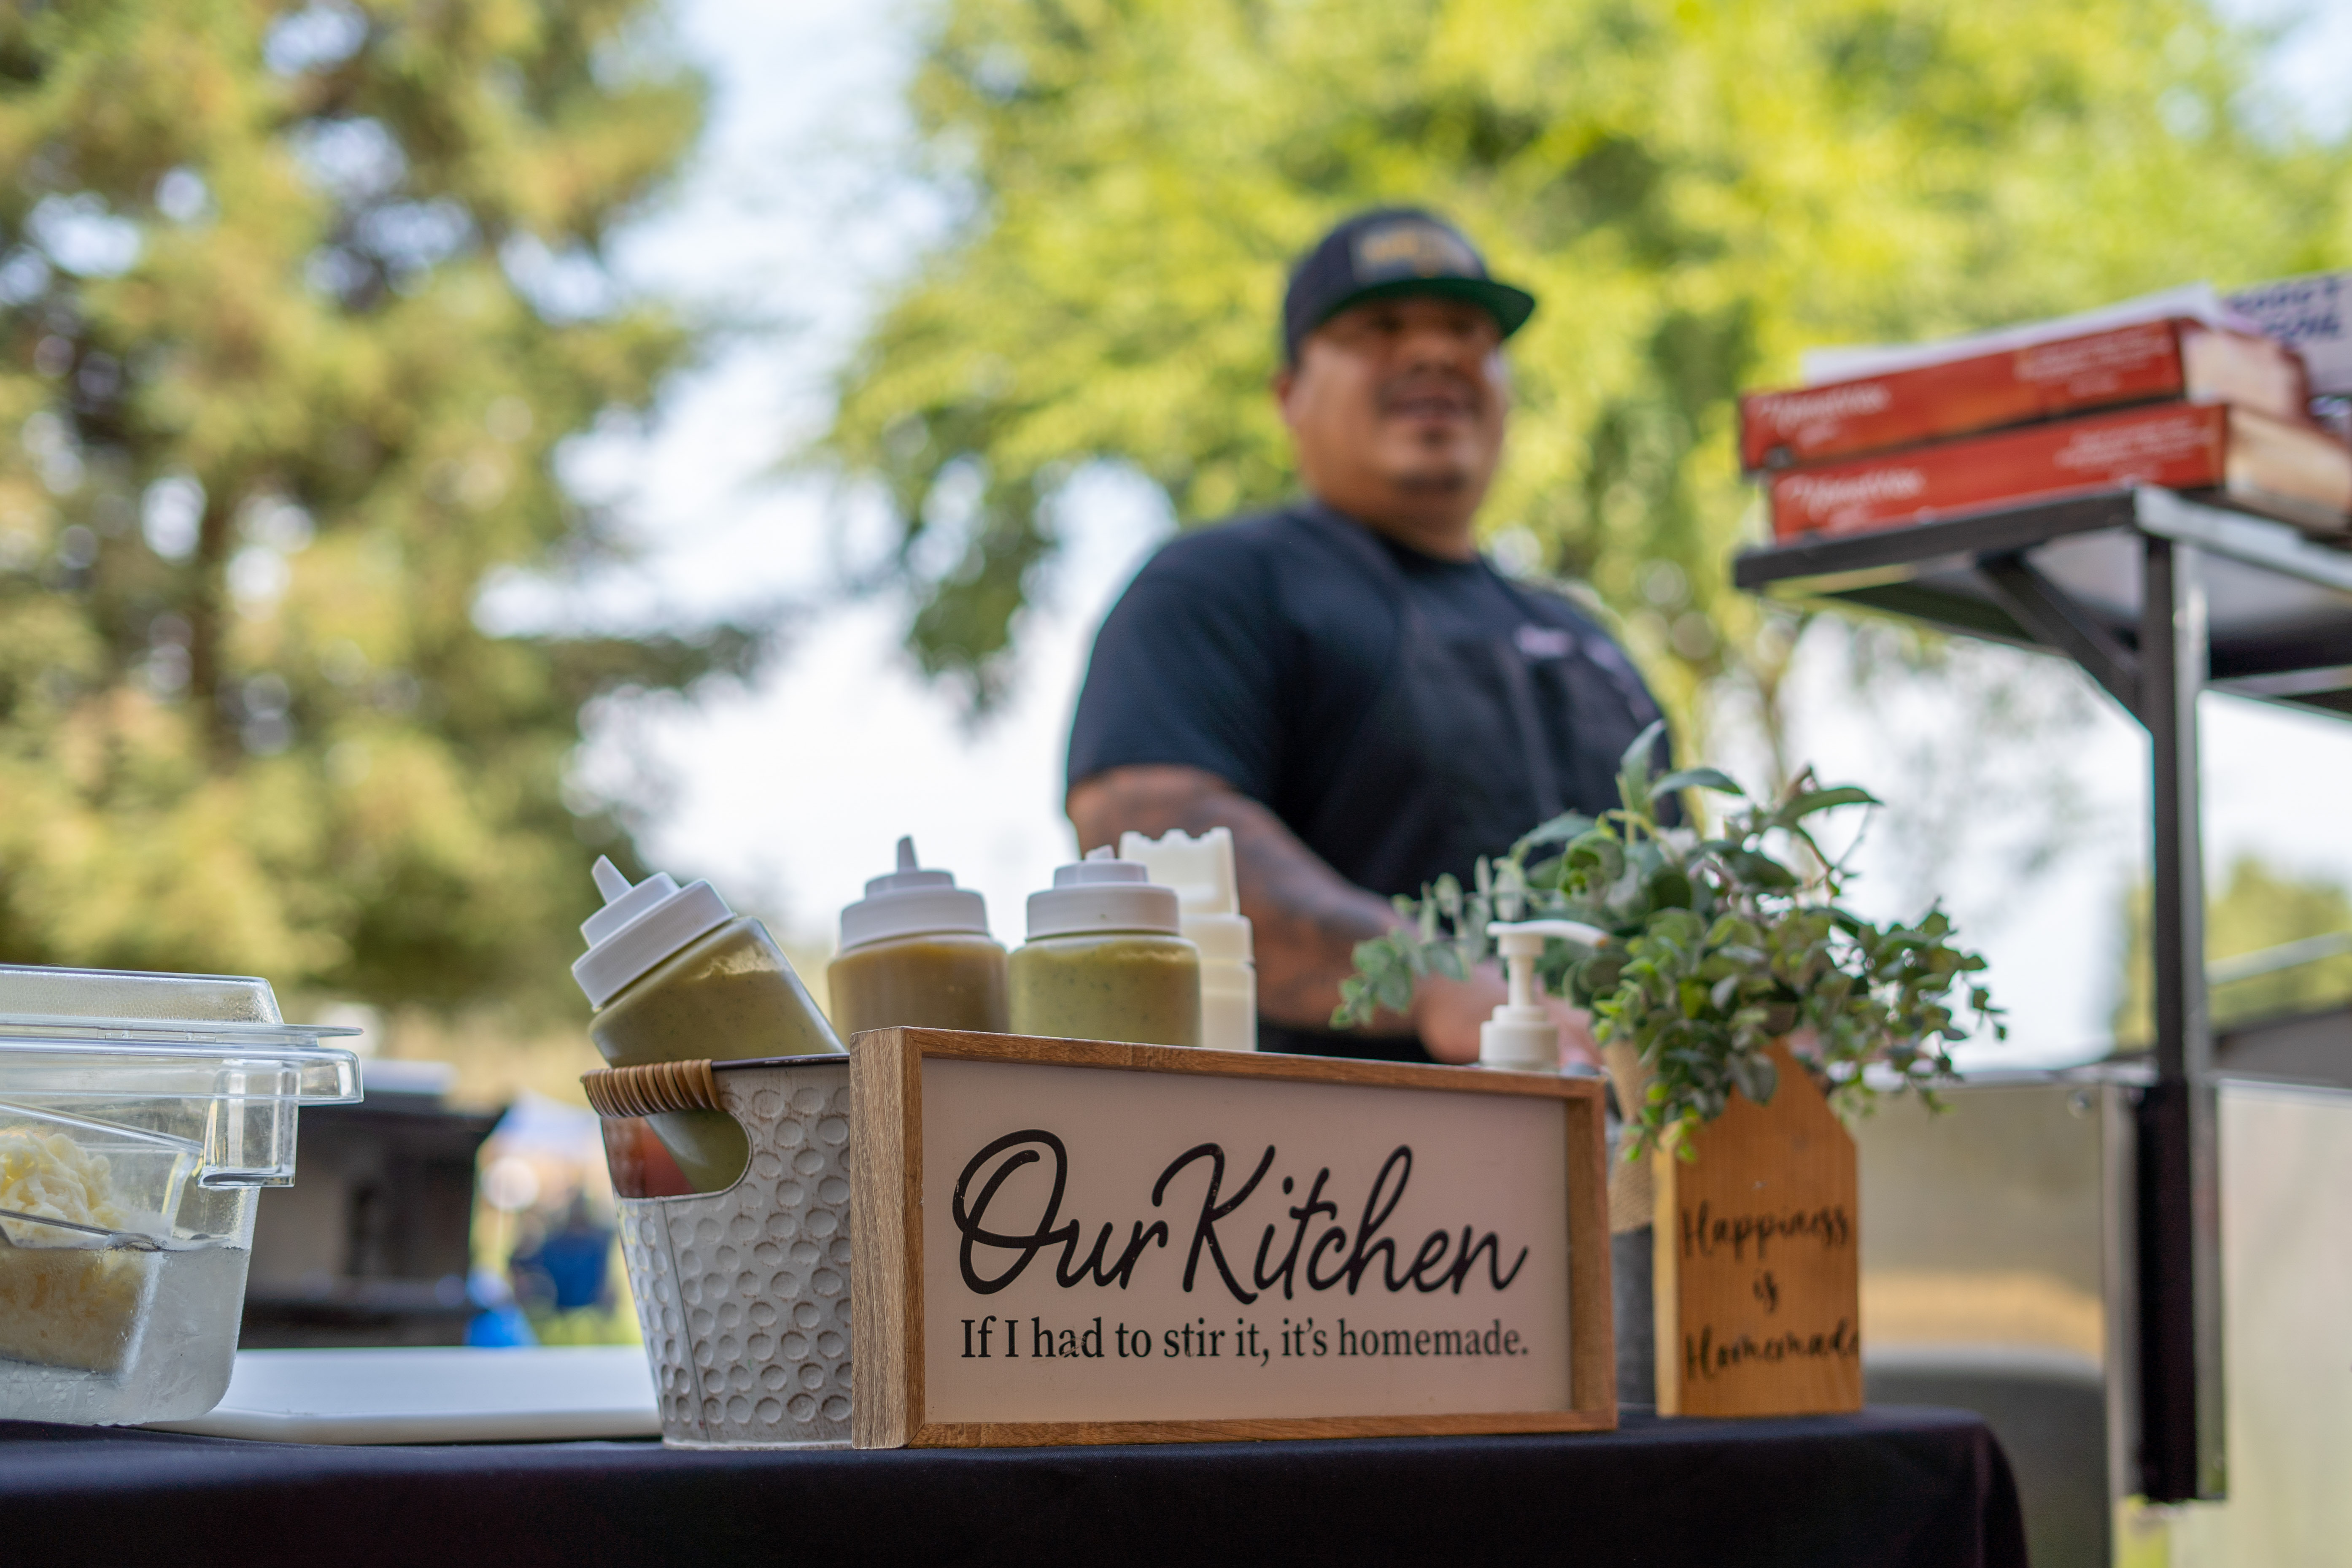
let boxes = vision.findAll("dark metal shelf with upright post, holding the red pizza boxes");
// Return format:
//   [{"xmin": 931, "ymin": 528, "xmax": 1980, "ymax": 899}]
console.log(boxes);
[{"xmin": 1731, "ymin": 489, "xmax": 2352, "ymax": 1502}]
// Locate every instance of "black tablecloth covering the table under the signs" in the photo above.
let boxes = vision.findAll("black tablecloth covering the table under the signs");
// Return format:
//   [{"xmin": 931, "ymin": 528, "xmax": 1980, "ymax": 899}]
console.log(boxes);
[{"xmin": 0, "ymin": 1408, "xmax": 2025, "ymax": 1568}]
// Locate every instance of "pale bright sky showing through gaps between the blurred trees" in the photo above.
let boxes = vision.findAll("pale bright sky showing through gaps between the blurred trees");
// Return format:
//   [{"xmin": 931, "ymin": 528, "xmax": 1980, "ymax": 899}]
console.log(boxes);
[{"xmin": 520, "ymin": 0, "xmax": 2352, "ymax": 1063}]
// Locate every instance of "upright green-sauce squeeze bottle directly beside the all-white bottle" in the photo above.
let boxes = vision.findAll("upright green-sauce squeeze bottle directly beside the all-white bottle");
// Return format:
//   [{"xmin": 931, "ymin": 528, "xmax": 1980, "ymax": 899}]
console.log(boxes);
[{"xmin": 1011, "ymin": 844, "xmax": 1200, "ymax": 1046}]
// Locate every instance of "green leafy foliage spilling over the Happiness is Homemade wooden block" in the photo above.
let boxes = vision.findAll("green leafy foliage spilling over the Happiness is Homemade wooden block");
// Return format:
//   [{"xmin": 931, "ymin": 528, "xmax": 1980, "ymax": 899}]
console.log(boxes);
[{"xmin": 1331, "ymin": 726, "xmax": 2006, "ymax": 1157}]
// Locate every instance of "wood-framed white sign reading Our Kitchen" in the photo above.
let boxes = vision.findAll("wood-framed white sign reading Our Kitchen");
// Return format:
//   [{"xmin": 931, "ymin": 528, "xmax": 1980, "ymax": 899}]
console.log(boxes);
[{"xmin": 849, "ymin": 1030, "xmax": 1616, "ymax": 1448}]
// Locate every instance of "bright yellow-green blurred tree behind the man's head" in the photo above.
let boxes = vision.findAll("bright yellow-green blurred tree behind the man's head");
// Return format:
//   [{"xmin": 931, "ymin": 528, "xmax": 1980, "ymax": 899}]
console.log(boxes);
[{"xmin": 823, "ymin": 0, "xmax": 2352, "ymax": 738}]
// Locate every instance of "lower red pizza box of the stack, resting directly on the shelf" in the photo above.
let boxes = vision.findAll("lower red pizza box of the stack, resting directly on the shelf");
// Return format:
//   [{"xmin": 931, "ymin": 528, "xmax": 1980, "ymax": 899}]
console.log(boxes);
[{"xmin": 1771, "ymin": 402, "xmax": 2352, "ymax": 541}]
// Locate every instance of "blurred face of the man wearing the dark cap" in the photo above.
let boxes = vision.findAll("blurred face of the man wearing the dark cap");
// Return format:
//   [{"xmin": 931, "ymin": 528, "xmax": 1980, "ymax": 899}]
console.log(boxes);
[{"xmin": 1275, "ymin": 294, "xmax": 1510, "ymax": 522}]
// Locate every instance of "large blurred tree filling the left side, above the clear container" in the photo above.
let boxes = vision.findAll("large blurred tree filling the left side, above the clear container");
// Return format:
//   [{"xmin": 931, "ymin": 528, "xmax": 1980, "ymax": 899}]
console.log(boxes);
[{"xmin": 0, "ymin": 0, "xmax": 750, "ymax": 1006}]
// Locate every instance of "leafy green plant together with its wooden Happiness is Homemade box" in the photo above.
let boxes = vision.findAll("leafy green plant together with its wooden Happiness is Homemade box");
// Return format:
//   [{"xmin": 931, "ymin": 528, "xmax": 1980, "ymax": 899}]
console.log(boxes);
[{"xmin": 1331, "ymin": 726, "xmax": 2006, "ymax": 1413}]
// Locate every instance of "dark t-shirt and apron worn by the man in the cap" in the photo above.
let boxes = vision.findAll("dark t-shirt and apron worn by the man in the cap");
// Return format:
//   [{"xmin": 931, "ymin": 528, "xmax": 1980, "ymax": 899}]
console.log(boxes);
[{"xmin": 1070, "ymin": 501, "xmax": 1658, "ymax": 1058}]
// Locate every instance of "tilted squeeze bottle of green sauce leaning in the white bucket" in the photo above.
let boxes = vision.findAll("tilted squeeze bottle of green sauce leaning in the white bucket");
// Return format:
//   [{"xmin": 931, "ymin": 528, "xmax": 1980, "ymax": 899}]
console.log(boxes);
[{"xmin": 572, "ymin": 858, "xmax": 842, "ymax": 1192}]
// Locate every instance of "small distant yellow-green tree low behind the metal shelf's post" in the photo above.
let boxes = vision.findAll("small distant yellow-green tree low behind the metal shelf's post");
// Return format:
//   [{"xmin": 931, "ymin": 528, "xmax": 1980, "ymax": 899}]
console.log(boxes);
[{"xmin": 2115, "ymin": 856, "xmax": 2352, "ymax": 1046}]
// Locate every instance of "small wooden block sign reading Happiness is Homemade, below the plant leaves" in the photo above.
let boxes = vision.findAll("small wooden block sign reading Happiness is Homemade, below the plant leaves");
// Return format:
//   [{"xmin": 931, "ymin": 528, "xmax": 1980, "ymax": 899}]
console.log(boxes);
[{"xmin": 1651, "ymin": 1044, "xmax": 1863, "ymax": 1415}]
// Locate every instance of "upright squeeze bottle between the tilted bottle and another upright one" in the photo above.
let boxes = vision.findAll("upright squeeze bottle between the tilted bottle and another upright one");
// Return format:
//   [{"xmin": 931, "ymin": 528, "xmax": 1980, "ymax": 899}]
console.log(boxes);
[{"xmin": 825, "ymin": 839, "xmax": 1011, "ymax": 1037}]
